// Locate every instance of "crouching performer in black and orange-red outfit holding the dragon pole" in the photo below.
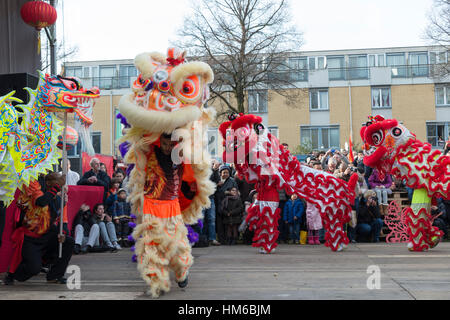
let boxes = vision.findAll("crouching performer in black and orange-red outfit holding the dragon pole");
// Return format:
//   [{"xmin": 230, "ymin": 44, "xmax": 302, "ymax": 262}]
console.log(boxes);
[{"xmin": 3, "ymin": 172, "xmax": 74, "ymax": 285}]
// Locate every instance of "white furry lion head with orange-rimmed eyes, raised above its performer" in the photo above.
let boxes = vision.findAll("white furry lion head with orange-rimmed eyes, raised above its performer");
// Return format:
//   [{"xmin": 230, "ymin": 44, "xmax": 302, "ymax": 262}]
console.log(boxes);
[{"xmin": 119, "ymin": 48, "xmax": 214, "ymax": 133}]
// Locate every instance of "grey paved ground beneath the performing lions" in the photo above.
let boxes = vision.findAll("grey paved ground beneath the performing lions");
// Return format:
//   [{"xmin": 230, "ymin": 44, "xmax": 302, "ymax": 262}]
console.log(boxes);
[{"xmin": 0, "ymin": 242, "xmax": 450, "ymax": 300}]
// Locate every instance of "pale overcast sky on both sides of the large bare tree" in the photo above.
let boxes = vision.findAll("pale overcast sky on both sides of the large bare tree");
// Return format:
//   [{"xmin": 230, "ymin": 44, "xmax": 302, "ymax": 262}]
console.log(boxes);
[{"xmin": 52, "ymin": 0, "xmax": 433, "ymax": 61}]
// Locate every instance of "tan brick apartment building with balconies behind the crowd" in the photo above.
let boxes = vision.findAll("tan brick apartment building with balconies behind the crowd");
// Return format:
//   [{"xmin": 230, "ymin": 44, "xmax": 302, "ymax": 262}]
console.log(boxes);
[{"xmin": 65, "ymin": 46, "xmax": 450, "ymax": 162}]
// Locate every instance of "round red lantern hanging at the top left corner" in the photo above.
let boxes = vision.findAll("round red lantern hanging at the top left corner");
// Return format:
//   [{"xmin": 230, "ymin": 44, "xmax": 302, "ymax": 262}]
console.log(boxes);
[{"xmin": 20, "ymin": 0, "xmax": 57, "ymax": 31}]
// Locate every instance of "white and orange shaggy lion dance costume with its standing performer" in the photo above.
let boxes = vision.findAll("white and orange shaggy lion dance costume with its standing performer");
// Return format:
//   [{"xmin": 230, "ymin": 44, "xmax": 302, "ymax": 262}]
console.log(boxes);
[{"xmin": 119, "ymin": 48, "xmax": 215, "ymax": 298}]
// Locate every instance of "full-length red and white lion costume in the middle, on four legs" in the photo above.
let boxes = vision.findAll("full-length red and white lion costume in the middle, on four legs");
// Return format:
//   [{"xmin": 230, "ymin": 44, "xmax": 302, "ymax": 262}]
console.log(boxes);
[{"xmin": 219, "ymin": 114, "xmax": 357, "ymax": 253}]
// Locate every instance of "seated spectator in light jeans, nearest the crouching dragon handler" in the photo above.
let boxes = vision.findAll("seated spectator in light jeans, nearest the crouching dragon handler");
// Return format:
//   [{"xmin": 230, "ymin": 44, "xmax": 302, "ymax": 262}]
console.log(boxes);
[{"xmin": 72, "ymin": 203, "xmax": 100, "ymax": 254}]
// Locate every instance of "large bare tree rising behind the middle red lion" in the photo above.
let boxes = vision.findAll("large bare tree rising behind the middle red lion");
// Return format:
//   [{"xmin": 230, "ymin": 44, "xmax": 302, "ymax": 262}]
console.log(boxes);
[{"xmin": 174, "ymin": 0, "xmax": 306, "ymax": 119}]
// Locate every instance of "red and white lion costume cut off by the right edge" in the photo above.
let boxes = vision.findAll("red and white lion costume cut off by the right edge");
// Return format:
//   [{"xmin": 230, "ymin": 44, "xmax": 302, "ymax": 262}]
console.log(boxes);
[{"xmin": 360, "ymin": 115, "xmax": 450, "ymax": 251}]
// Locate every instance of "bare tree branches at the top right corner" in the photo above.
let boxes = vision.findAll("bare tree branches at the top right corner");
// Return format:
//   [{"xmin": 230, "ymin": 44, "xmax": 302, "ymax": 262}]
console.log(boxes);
[{"xmin": 425, "ymin": 0, "xmax": 450, "ymax": 78}]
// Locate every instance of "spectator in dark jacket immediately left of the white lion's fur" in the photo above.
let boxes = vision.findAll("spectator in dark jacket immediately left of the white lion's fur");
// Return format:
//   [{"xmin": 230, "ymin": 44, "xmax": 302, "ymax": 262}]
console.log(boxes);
[{"xmin": 112, "ymin": 189, "xmax": 131, "ymax": 247}]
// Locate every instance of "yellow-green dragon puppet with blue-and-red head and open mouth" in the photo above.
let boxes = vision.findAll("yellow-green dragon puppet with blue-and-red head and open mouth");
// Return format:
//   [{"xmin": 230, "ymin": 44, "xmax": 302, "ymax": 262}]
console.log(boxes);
[{"xmin": 0, "ymin": 72, "xmax": 99, "ymax": 205}]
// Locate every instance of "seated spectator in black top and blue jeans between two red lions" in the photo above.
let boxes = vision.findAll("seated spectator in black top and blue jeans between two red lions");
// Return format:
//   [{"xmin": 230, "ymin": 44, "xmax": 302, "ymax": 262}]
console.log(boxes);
[{"xmin": 356, "ymin": 190, "xmax": 383, "ymax": 242}]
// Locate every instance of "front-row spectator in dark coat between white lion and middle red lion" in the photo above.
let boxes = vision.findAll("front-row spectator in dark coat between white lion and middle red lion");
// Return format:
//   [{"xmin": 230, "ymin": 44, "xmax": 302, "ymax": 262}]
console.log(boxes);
[{"xmin": 220, "ymin": 187, "xmax": 244, "ymax": 245}]
